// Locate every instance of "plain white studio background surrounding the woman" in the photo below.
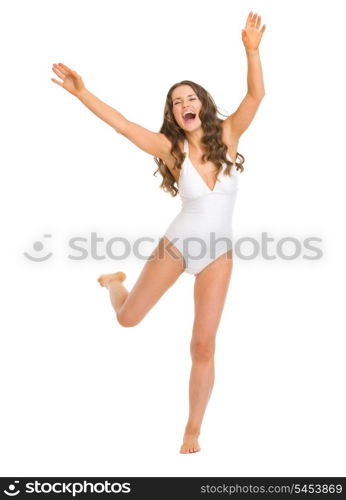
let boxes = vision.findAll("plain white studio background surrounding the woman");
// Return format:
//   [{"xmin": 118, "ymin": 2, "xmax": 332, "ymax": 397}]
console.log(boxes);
[{"xmin": 0, "ymin": 0, "xmax": 346, "ymax": 477}]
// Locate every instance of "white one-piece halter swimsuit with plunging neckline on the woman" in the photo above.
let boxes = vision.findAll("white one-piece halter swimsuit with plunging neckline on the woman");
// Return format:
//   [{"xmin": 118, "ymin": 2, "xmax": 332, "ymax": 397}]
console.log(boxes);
[{"xmin": 165, "ymin": 139, "xmax": 239, "ymax": 275}]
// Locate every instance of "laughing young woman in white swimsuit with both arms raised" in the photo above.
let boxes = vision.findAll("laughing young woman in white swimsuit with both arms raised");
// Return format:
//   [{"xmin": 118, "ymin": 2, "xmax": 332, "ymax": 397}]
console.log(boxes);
[{"xmin": 52, "ymin": 12, "xmax": 265, "ymax": 453}]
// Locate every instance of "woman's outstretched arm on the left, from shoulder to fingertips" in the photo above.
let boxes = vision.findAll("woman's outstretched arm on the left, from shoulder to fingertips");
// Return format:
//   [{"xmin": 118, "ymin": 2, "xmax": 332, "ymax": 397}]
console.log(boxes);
[{"xmin": 52, "ymin": 63, "xmax": 171, "ymax": 159}]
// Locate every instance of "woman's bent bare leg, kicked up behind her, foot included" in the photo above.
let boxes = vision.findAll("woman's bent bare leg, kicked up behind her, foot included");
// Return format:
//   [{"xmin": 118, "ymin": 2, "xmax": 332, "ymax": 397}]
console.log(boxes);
[{"xmin": 98, "ymin": 237, "xmax": 184, "ymax": 327}]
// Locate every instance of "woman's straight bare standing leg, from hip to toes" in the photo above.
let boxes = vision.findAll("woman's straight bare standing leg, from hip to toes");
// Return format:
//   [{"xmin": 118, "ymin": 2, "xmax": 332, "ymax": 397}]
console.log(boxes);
[{"xmin": 180, "ymin": 250, "xmax": 233, "ymax": 453}]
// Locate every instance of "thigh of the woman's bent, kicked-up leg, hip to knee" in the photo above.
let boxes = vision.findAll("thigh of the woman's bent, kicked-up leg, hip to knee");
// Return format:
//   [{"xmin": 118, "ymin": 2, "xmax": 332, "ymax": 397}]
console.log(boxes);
[{"xmin": 117, "ymin": 237, "xmax": 184, "ymax": 326}]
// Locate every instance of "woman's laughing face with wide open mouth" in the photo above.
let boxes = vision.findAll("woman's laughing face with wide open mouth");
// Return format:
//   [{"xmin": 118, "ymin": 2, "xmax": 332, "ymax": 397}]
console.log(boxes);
[{"xmin": 172, "ymin": 85, "xmax": 202, "ymax": 132}]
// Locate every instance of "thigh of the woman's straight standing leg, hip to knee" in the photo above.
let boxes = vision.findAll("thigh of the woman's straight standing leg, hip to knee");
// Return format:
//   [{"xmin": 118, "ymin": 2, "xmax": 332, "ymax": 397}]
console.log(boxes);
[{"xmin": 191, "ymin": 250, "xmax": 233, "ymax": 347}]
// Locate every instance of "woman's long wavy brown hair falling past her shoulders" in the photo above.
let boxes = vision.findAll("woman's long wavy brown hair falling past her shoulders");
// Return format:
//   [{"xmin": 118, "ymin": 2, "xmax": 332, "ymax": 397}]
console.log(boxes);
[{"xmin": 153, "ymin": 80, "xmax": 245, "ymax": 196}]
